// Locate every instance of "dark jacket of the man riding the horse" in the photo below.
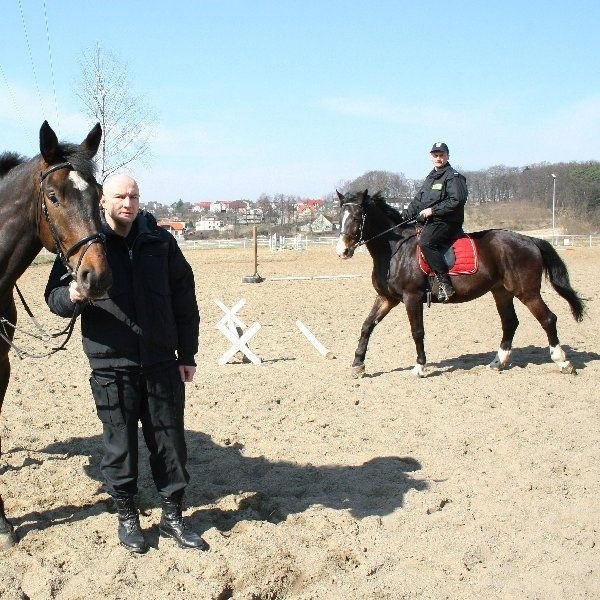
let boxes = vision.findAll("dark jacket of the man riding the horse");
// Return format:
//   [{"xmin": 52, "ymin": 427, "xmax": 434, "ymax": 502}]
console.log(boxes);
[{"xmin": 402, "ymin": 163, "xmax": 467, "ymax": 225}]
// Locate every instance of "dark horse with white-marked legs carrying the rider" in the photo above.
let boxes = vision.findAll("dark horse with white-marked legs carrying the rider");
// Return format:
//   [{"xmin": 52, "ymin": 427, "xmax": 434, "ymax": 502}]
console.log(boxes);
[{"xmin": 336, "ymin": 190, "xmax": 584, "ymax": 377}]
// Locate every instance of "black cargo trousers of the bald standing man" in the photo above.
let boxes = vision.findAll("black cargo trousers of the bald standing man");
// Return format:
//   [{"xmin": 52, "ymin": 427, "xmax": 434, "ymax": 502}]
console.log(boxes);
[{"xmin": 90, "ymin": 362, "xmax": 189, "ymax": 498}]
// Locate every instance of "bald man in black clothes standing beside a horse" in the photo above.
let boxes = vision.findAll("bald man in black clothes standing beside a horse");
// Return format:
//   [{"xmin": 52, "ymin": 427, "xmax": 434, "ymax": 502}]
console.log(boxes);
[{"xmin": 45, "ymin": 175, "xmax": 208, "ymax": 553}]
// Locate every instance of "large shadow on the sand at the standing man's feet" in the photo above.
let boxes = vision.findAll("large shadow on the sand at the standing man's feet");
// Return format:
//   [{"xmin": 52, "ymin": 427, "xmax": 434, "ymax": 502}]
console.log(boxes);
[{"xmin": 12, "ymin": 430, "xmax": 429, "ymax": 545}]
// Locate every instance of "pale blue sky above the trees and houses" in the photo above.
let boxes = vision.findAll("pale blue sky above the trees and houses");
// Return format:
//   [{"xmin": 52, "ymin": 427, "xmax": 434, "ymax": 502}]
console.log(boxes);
[{"xmin": 0, "ymin": 0, "xmax": 600, "ymax": 203}]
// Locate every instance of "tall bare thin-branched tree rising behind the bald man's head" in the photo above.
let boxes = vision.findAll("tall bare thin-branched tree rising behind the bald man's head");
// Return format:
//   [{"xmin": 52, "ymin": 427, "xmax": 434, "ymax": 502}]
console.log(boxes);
[{"xmin": 75, "ymin": 43, "xmax": 155, "ymax": 182}]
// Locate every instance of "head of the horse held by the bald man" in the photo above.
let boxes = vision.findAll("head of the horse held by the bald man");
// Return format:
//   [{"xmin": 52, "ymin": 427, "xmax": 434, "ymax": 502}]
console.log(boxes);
[{"xmin": 37, "ymin": 121, "xmax": 112, "ymax": 298}]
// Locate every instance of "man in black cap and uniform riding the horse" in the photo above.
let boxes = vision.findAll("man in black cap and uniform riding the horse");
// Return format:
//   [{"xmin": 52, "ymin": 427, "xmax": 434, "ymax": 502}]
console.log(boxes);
[{"xmin": 402, "ymin": 142, "xmax": 468, "ymax": 302}]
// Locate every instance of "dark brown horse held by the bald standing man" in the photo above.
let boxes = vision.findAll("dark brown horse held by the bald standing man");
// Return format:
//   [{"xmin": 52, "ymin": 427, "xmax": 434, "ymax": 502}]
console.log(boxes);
[{"xmin": 0, "ymin": 121, "xmax": 112, "ymax": 549}]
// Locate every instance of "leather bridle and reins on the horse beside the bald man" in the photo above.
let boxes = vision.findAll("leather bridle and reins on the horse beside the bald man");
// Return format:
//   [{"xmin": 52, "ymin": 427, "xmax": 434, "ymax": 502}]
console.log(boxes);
[{"xmin": 0, "ymin": 162, "xmax": 106, "ymax": 358}]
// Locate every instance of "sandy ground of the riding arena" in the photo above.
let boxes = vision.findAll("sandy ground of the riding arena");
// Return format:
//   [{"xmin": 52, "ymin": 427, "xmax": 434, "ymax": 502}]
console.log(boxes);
[{"xmin": 0, "ymin": 248, "xmax": 600, "ymax": 600}]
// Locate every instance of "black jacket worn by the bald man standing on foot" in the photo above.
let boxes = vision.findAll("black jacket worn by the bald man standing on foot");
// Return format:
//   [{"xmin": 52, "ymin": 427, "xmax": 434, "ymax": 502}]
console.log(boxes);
[{"xmin": 45, "ymin": 211, "xmax": 200, "ymax": 369}]
